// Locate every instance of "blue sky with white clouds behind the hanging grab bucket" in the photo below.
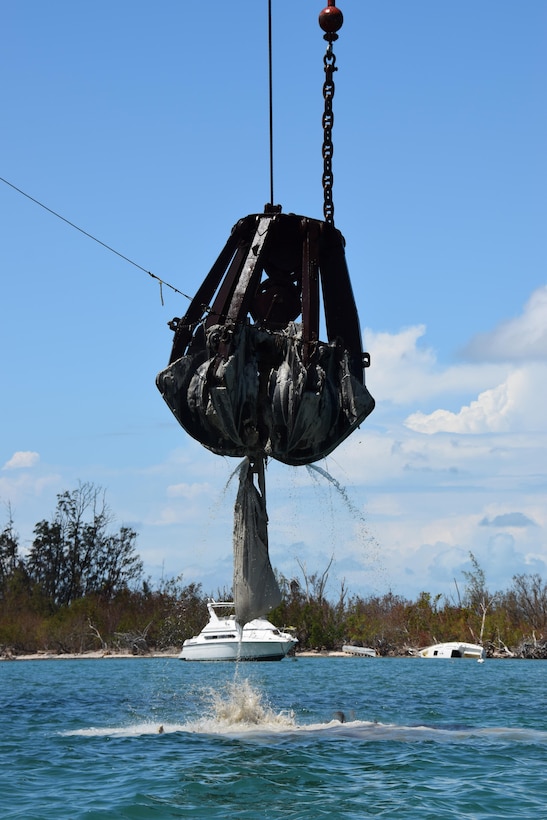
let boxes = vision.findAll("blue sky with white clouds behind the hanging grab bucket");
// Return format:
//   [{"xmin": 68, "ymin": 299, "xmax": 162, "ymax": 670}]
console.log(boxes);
[{"xmin": 0, "ymin": 0, "xmax": 547, "ymax": 599}]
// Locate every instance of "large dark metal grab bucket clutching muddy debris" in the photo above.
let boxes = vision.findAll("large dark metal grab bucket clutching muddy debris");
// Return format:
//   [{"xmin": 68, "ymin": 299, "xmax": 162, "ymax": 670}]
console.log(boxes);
[{"xmin": 157, "ymin": 211, "xmax": 374, "ymax": 465}]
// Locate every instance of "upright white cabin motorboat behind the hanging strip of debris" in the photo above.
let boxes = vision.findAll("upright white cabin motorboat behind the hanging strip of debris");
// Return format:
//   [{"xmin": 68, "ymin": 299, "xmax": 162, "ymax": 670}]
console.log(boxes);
[{"xmin": 179, "ymin": 599, "xmax": 298, "ymax": 661}]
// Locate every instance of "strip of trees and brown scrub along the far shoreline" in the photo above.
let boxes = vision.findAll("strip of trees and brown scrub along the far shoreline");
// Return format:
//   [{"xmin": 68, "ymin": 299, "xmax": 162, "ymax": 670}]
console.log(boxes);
[{"xmin": 0, "ymin": 483, "xmax": 547, "ymax": 658}]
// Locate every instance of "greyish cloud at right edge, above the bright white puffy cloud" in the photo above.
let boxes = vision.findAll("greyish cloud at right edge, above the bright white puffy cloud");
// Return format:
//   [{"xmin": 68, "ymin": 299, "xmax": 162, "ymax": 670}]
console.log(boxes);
[{"xmin": 463, "ymin": 285, "xmax": 547, "ymax": 362}]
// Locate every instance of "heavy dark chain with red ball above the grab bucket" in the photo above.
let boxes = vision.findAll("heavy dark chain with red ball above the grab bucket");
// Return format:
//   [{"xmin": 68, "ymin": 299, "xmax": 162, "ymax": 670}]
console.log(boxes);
[{"xmin": 319, "ymin": 0, "xmax": 344, "ymax": 225}]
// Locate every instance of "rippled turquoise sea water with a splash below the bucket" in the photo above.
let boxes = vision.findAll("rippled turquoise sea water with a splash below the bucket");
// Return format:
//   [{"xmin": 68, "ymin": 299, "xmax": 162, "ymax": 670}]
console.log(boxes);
[{"xmin": 0, "ymin": 657, "xmax": 547, "ymax": 820}]
